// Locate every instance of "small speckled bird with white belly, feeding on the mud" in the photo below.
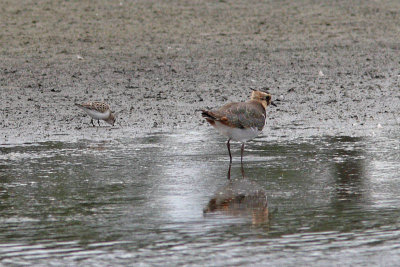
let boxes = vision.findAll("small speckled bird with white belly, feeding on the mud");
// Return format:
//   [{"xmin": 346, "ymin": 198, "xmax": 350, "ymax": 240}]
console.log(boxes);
[{"xmin": 75, "ymin": 101, "xmax": 115, "ymax": 126}]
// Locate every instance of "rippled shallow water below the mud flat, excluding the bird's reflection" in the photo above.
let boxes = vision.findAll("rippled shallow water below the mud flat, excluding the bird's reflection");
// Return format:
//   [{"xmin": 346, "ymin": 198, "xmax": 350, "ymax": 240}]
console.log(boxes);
[{"xmin": 0, "ymin": 130, "xmax": 400, "ymax": 266}]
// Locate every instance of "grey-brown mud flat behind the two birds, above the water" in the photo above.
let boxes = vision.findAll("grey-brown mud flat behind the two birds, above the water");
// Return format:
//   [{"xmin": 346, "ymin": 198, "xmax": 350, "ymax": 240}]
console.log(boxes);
[{"xmin": 0, "ymin": 0, "xmax": 400, "ymax": 143}]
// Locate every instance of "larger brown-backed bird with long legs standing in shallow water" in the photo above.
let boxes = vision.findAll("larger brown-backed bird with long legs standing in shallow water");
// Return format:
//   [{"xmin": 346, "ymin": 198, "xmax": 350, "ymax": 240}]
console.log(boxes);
[{"xmin": 201, "ymin": 90, "xmax": 276, "ymax": 179}]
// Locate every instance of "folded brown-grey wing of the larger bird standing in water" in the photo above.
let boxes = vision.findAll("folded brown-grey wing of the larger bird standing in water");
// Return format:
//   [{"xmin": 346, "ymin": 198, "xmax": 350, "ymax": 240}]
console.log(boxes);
[{"xmin": 208, "ymin": 100, "xmax": 266, "ymax": 131}]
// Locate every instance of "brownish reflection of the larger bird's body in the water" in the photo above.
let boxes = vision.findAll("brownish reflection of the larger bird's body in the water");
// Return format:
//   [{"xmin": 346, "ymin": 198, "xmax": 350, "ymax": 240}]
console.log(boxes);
[{"xmin": 203, "ymin": 178, "xmax": 268, "ymax": 225}]
